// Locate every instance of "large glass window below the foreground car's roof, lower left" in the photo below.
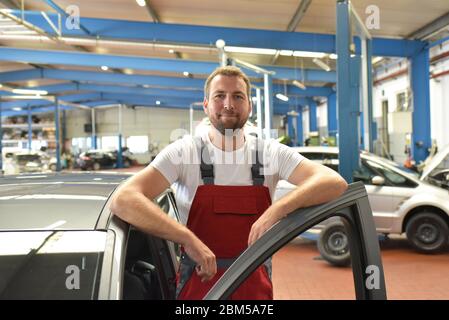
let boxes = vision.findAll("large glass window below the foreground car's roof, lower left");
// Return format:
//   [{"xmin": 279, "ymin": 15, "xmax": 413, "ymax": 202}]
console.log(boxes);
[{"xmin": 0, "ymin": 231, "xmax": 106, "ymax": 300}]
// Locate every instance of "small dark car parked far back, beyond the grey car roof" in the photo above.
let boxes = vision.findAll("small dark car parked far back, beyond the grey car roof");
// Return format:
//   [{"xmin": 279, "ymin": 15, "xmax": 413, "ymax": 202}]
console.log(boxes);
[{"xmin": 77, "ymin": 150, "xmax": 133, "ymax": 170}]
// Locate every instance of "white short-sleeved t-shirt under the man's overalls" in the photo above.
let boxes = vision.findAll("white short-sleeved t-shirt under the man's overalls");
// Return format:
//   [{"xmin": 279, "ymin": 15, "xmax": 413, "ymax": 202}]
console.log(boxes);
[{"xmin": 150, "ymin": 133, "xmax": 304, "ymax": 224}]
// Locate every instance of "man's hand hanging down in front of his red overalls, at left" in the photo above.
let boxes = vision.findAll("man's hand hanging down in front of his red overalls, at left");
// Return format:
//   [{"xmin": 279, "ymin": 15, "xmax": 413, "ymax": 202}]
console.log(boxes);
[{"xmin": 184, "ymin": 233, "xmax": 217, "ymax": 282}]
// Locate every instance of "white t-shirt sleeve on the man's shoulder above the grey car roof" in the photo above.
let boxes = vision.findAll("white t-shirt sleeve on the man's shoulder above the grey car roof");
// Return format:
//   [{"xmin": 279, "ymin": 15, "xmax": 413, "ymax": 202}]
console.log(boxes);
[{"xmin": 150, "ymin": 139, "xmax": 183, "ymax": 184}]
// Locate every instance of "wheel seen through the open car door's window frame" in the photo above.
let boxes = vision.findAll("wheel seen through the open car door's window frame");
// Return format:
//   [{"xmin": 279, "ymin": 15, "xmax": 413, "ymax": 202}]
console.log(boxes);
[{"xmin": 317, "ymin": 221, "xmax": 351, "ymax": 267}]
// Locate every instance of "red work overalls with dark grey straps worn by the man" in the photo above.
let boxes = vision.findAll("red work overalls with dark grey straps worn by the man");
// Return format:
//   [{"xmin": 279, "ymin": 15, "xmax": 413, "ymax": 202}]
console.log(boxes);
[{"xmin": 177, "ymin": 141, "xmax": 273, "ymax": 300}]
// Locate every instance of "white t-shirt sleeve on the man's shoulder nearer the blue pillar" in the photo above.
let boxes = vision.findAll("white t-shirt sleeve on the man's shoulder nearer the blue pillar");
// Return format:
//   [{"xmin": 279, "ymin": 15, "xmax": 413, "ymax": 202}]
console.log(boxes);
[{"xmin": 268, "ymin": 140, "xmax": 305, "ymax": 180}]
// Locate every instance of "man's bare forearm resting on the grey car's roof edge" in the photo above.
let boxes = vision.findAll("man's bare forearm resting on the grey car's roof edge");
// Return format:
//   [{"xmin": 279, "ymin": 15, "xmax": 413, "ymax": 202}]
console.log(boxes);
[{"xmin": 111, "ymin": 190, "xmax": 193, "ymax": 245}]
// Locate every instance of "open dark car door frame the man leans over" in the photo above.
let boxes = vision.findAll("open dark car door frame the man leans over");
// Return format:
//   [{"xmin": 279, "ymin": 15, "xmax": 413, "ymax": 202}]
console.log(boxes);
[{"xmin": 205, "ymin": 182, "xmax": 386, "ymax": 300}]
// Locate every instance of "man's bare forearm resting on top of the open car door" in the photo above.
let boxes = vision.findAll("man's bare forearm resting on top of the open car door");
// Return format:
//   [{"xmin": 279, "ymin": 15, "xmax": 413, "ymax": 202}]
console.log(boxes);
[{"xmin": 273, "ymin": 174, "xmax": 347, "ymax": 219}]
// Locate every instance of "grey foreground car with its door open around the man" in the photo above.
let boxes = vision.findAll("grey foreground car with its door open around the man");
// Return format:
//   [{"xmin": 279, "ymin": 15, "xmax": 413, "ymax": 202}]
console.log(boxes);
[{"xmin": 0, "ymin": 173, "xmax": 386, "ymax": 299}]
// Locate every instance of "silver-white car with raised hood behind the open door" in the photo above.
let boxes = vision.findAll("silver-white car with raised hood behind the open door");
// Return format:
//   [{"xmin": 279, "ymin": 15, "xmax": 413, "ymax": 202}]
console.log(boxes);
[{"xmin": 275, "ymin": 147, "xmax": 449, "ymax": 265}]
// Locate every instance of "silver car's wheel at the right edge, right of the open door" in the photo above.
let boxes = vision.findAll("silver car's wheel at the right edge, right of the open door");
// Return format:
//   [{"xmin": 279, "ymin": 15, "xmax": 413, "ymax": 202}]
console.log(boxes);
[{"xmin": 405, "ymin": 212, "xmax": 449, "ymax": 253}]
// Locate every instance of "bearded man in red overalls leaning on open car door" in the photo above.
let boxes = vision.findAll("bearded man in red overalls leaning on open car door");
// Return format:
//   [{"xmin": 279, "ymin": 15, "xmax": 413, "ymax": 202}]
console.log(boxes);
[{"xmin": 112, "ymin": 66, "xmax": 347, "ymax": 299}]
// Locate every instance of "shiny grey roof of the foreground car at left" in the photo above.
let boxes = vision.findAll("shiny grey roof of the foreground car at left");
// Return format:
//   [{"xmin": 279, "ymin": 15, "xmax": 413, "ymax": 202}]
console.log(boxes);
[{"xmin": 0, "ymin": 173, "xmax": 130, "ymax": 230}]
